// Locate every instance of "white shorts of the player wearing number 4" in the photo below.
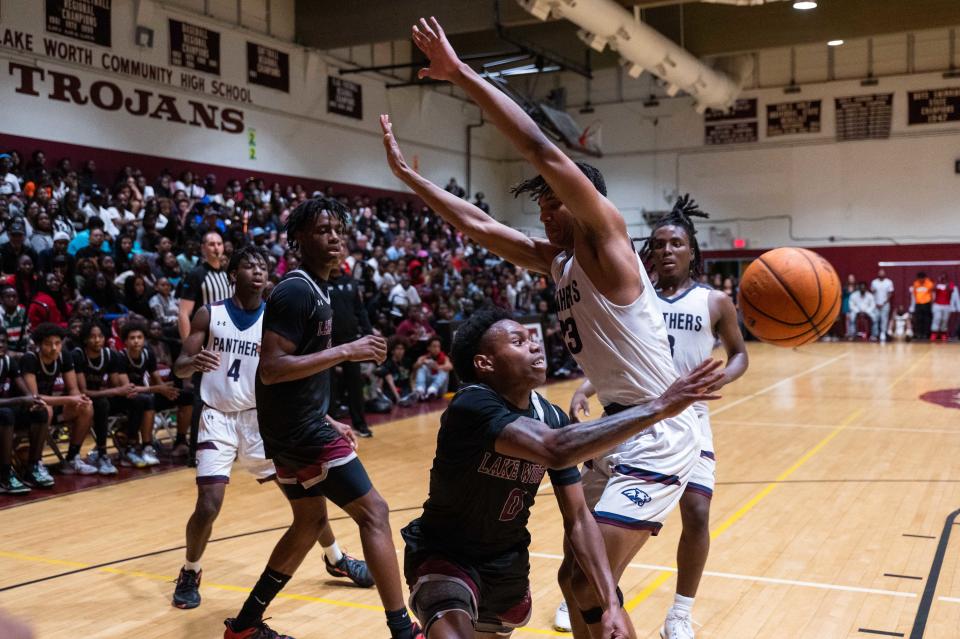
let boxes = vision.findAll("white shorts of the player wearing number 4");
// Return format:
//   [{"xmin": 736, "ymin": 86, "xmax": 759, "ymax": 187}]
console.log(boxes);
[{"xmin": 197, "ymin": 406, "xmax": 276, "ymax": 485}]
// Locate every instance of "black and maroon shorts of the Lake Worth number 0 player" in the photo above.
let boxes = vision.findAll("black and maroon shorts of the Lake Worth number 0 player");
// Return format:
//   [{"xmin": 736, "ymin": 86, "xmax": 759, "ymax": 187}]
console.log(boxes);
[{"xmin": 400, "ymin": 519, "xmax": 533, "ymax": 635}]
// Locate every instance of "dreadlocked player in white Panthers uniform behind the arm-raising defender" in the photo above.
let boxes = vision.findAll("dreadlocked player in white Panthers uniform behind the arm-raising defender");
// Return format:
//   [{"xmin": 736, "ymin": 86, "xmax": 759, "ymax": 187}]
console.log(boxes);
[{"xmin": 558, "ymin": 196, "xmax": 748, "ymax": 639}]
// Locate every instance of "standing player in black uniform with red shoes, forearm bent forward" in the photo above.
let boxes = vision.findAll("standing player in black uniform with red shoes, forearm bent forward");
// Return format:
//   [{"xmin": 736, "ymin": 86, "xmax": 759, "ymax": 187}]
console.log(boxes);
[{"xmin": 223, "ymin": 197, "xmax": 422, "ymax": 639}]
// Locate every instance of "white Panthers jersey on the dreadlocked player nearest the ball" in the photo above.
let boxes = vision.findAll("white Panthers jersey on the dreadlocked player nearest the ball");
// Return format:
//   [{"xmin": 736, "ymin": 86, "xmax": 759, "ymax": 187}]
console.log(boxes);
[{"xmin": 657, "ymin": 284, "xmax": 716, "ymax": 415}]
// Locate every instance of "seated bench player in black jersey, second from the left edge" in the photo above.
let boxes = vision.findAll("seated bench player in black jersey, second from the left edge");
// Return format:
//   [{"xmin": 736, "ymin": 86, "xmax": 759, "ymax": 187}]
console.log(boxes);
[{"xmin": 19, "ymin": 323, "xmax": 97, "ymax": 475}]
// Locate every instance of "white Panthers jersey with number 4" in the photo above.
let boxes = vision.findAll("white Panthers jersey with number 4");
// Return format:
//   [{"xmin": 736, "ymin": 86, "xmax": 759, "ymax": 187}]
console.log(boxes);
[{"xmin": 200, "ymin": 299, "xmax": 266, "ymax": 413}]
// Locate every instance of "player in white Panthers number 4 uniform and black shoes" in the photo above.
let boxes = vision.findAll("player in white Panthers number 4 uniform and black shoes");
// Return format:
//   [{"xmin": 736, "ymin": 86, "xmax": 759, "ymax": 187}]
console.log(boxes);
[{"xmin": 173, "ymin": 245, "xmax": 373, "ymax": 609}]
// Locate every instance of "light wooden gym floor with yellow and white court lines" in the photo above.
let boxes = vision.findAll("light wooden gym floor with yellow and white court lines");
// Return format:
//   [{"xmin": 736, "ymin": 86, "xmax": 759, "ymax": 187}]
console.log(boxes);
[{"xmin": 0, "ymin": 343, "xmax": 960, "ymax": 639}]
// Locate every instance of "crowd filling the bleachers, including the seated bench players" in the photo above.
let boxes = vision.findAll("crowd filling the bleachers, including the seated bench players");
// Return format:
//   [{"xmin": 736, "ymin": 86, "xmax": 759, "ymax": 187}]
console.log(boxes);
[{"xmin": 0, "ymin": 150, "xmax": 576, "ymax": 492}]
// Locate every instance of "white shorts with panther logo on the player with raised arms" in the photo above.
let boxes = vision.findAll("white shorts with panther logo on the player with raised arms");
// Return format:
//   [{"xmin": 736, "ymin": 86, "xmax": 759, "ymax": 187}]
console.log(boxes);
[{"xmin": 583, "ymin": 405, "xmax": 701, "ymax": 535}]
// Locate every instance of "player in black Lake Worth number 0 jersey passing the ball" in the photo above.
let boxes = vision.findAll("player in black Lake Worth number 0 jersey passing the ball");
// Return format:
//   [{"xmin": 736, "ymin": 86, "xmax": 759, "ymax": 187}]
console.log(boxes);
[{"xmin": 402, "ymin": 307, "xmax": 722, "ymax": 639}]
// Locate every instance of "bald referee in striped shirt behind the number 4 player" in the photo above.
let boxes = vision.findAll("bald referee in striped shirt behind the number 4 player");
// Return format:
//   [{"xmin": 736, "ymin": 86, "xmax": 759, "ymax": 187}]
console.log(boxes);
[{"xmin": 173, "ymin": 231, "xmax": 233, "ymax": 467}]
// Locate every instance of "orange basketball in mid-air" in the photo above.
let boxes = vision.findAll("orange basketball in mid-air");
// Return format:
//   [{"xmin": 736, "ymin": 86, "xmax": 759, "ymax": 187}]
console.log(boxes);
[{"xmin": 737, "ymin": 247, "xmax": 840, "ymax": 347}]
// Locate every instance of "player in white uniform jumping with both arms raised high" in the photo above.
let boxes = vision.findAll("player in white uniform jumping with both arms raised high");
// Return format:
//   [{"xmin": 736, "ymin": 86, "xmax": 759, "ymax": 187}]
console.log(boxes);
[{"xmin": 381, "ymin": 18, "xmax": 700, "ymax": 638}]
